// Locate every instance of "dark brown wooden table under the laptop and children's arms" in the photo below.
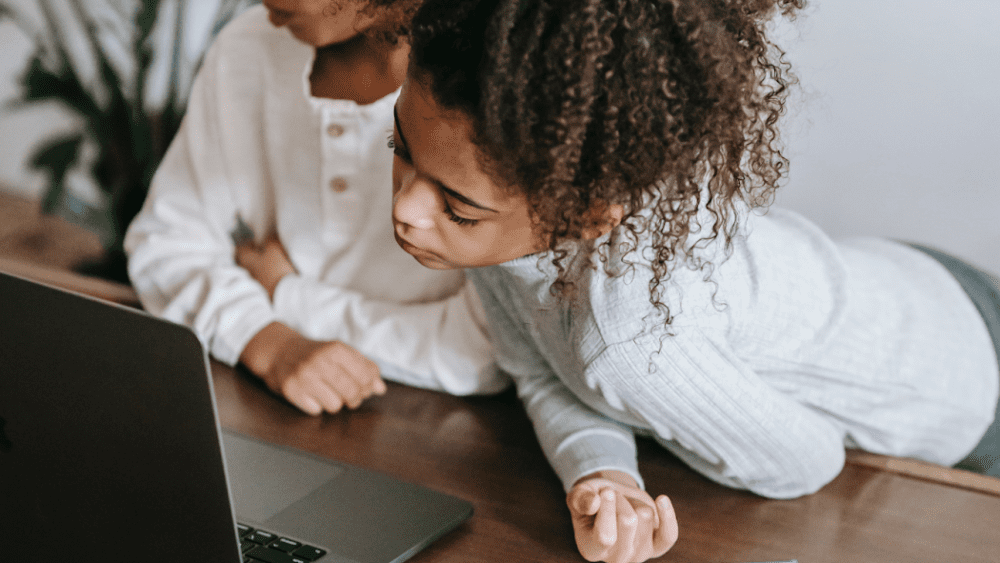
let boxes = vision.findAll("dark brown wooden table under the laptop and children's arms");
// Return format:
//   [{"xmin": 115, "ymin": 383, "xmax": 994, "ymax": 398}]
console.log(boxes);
[{"xmin": 213, "ymin": 364, "xmax": 1000, "ymax": 563}]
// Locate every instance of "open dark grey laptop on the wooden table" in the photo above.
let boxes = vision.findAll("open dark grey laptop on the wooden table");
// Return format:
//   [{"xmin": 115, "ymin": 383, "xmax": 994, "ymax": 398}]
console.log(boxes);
[{"xmin": 0, "ymin": 272, "xmax": 472, "ymax": 563}]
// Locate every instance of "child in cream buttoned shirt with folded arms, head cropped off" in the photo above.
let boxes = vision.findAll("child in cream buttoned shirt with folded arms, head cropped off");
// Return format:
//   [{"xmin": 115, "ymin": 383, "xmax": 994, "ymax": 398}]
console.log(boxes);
[{"xmin": 126, "ymin": 0, "xmax": 507, "ymax": 414}]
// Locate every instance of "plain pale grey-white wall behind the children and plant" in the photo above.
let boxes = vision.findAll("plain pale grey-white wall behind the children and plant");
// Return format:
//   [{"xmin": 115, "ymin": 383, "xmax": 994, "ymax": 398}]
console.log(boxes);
[{"xmin": 0, "ymin": 0, "xmax": 1000, "ymax": 272}]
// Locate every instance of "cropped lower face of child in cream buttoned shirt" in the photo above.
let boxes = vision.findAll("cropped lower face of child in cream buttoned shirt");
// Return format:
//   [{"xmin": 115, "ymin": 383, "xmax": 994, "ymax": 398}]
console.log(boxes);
[{"xmin": 263, "ymin": 0, "xmax": 375, "ymax": 47}]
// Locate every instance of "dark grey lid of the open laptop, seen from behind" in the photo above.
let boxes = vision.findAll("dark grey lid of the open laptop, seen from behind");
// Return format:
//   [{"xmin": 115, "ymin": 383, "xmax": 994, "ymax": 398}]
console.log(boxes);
[{"xmin": 0, "ymin": 273, "xmax": 240, "ymax": 563}]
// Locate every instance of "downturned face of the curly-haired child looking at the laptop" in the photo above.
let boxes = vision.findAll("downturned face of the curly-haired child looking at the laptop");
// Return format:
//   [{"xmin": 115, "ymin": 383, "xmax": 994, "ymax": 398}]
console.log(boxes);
[{"xmin": 392, "ymin": 79, "xmax": 543, "ymax": 270}]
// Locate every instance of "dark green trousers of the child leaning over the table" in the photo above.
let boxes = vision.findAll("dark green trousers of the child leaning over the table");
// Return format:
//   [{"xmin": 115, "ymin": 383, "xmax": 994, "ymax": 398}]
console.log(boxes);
[{"xmin": 910, "ymin": 244, "xmax": 1000, "ymax": 477}]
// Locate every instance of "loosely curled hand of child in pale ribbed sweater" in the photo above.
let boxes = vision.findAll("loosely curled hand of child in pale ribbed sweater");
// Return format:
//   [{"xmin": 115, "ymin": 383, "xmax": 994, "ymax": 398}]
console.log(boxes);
[{"xmin": 566, "ymin": 471, "xmax": 678, "ymax": 563}]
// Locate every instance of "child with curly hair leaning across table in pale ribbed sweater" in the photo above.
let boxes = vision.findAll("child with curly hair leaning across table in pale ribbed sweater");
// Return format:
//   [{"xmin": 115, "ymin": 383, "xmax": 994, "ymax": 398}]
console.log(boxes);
[{"xmin": 393, "ymin": 0, "xmax": 1000, "ymax": 562}]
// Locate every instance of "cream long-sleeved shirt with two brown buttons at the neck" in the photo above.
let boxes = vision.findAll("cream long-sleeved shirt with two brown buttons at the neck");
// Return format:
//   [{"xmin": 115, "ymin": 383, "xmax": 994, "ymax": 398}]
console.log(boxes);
[{"xmin": 125, "ymin": 6, "xmax": 509, "ymax": 394}]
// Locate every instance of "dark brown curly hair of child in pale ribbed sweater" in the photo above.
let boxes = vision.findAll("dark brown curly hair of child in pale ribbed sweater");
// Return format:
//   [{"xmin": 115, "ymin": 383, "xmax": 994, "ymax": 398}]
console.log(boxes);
[{"xmin": 410, "ymin": 0, "xmax": 804, "ymax": 323}]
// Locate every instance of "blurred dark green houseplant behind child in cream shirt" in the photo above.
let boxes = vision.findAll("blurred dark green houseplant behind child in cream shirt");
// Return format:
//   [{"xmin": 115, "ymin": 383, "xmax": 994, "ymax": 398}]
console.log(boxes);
[{"xmin": 0, "ymin": 0, "xmax": 252, "ymax": 282}]
